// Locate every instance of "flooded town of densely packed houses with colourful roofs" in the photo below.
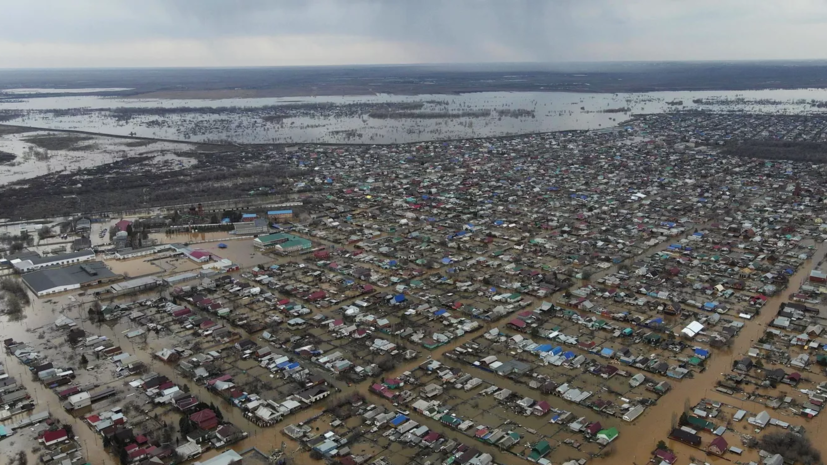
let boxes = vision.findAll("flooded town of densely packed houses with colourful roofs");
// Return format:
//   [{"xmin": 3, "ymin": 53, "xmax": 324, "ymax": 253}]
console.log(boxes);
[{"xmin": 0, "ymin": 103, "xmax": 827, "ymax": 465}]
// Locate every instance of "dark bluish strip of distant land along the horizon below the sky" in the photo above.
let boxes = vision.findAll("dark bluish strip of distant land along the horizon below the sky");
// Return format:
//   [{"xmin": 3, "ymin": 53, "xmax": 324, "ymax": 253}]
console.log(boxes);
[{"xmin": 6, "ymin": 61, "xmax": 827, "ymax": 98}]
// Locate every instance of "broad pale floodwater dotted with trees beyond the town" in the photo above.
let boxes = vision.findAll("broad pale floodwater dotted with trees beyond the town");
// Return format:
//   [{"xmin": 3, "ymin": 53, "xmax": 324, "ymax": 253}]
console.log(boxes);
[{"xmin": 0, "ymin": 89, "xmax": 827, "ymax": 143}]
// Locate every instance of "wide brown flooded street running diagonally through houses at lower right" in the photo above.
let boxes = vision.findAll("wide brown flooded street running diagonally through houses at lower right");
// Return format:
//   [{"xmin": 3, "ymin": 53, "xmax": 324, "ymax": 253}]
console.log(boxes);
[{"xmin": 595, "ymin": 239, "xmax": 827, "ymax": 465}]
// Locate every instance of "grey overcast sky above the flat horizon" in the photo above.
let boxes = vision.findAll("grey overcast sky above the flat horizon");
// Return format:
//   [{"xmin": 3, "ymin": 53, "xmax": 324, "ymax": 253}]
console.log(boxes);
[{"xmin": 0, "ymin": 0, "xmax": 827, "ymax": 68}]
